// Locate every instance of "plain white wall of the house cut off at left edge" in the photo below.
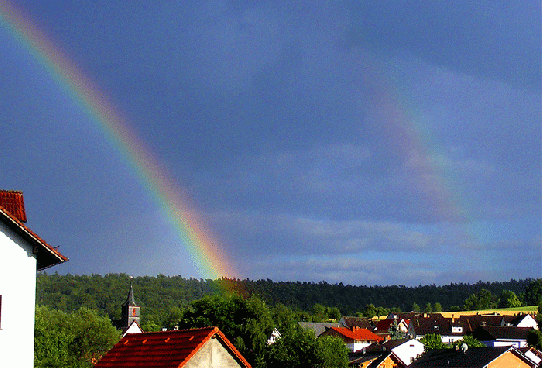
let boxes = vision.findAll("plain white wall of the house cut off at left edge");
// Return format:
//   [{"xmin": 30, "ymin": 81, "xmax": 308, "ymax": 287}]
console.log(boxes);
[{"xmin": 0, "ymin": 223, "xmax": 36, "ymax": 368}]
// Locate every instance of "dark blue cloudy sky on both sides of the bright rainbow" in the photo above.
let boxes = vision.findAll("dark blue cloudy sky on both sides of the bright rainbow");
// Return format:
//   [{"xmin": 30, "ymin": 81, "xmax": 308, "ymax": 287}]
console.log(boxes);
[{"xmin": 0, "ymin": 0, "xmax": 542, "ymax": 285}]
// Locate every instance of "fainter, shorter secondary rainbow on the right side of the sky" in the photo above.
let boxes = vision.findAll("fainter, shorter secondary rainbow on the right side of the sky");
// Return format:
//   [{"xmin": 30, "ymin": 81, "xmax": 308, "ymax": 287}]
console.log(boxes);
[{"xmin": 356, "ymin": 51, "xmax": 480, "ymax": 249}]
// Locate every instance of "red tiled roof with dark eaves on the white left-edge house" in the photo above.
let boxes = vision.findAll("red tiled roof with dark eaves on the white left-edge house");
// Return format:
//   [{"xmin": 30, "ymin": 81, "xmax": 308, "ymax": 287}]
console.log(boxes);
[{"xmin": 0, "ymin": 190, "xmax": 68, "ymax": 271}]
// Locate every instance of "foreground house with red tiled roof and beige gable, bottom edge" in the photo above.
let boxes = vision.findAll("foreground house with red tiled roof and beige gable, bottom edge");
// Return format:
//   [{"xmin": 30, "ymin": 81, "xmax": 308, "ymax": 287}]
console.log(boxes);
[{"xmin": 95, "ymin": 327, "xmax": 250, "ymax": 368}]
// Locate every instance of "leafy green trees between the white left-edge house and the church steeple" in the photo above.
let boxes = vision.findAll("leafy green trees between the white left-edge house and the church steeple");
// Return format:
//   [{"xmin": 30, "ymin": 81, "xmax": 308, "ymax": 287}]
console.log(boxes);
[{"xmin": 34, "ymin": 306, "xmax": 120, "ymax": 368}]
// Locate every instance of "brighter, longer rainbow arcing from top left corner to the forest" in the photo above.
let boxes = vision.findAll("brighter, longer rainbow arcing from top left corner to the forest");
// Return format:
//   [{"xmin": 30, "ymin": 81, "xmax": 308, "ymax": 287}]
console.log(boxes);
[{"xmin": 0, "ymin": 1, "xmax": 236, "ymax": 279}]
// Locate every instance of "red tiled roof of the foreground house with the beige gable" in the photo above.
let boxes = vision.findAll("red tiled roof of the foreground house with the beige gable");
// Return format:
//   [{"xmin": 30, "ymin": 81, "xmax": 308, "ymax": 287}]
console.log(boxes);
[{"xmin": 95, "ymin": 327, "xmax": 251, "ymax": 368}]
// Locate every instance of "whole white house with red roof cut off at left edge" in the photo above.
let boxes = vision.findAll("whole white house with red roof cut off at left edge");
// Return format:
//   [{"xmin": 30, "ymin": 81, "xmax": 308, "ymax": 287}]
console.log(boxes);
[{"xmin": 0, "ymin": 190, "xmax": 68, "ymax": 368}]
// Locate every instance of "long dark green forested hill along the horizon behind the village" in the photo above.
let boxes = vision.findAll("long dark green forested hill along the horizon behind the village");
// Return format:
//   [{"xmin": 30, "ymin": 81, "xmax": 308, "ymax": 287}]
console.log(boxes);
[{"xmin": 36, "ymin": 272, "xmax": 542, "ymax": 320}]
